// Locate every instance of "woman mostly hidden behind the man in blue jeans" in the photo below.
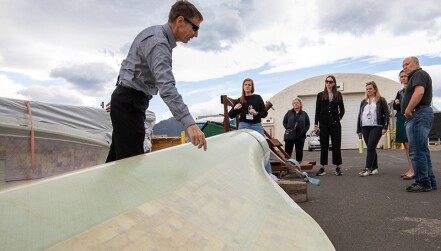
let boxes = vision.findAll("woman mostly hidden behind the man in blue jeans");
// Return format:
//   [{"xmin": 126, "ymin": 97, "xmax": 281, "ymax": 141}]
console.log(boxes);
[{"xmin": 393, "ymin": 70, "xmax": 415, "ymax": 180}]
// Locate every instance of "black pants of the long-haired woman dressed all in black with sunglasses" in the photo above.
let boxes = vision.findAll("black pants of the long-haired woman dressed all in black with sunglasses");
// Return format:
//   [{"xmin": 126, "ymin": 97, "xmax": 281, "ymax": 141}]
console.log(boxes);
[{"xmin": 320, "ymin": 122, "xmax": 342, "ymax": 166}]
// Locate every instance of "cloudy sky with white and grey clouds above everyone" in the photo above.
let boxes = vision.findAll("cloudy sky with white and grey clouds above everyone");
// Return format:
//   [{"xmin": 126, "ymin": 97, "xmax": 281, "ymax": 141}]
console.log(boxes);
[{"xmin": 0, "ymin": 0, "xmax": 441, "ymax": 122}]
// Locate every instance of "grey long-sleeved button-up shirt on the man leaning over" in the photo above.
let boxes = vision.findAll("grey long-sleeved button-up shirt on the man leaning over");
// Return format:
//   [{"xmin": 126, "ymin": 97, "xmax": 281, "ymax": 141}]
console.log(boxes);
[{"xmin": 118, "ymin": 24, "xmax": 195, "ymax": 127}]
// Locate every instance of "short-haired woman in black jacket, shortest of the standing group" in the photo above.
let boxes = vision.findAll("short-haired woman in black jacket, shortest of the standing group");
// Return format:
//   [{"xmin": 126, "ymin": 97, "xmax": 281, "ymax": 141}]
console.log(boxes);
[{"xmin": 283, "ymin": 98, "xmax": 310, "ymax": 162}]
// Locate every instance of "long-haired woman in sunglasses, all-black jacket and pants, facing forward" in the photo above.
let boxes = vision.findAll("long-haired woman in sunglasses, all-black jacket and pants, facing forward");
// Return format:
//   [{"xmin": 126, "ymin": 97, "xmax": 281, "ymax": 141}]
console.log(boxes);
[{"xmin": 314, "ymin": 75, "xmax": 345, "ymax": 176}]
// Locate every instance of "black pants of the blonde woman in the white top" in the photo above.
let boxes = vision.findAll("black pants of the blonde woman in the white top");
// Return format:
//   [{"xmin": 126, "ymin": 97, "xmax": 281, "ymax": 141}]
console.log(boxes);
[{"xmin": 361, "ymin": 126, "xmax": 383, "ymax": 170}]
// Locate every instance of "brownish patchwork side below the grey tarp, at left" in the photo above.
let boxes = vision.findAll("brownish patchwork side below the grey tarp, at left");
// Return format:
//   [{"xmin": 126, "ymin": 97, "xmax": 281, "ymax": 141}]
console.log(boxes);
[{"xmin": 0, "ymin": 135, "xmax": 106, "ymax": 181}]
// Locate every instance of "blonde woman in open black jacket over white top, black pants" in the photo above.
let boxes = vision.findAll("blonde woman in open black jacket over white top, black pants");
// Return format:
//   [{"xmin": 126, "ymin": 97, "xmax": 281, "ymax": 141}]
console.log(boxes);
[{"xmin": 357, "ymin": 81, "xmax": 389, "ymax": 177}]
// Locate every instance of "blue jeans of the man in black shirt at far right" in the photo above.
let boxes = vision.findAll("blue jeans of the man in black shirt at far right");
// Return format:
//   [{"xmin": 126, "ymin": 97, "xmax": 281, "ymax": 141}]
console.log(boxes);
[{"xmin": 405, "ymin": 107, "xmax": 437, "ymax": 187}]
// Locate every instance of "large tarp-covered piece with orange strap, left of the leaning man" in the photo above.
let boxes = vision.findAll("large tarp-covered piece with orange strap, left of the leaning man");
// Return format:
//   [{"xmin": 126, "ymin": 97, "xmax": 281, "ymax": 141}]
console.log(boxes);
[{"xmin": 0, "ymin": 98, "xmax": 112, "ymax": 182}]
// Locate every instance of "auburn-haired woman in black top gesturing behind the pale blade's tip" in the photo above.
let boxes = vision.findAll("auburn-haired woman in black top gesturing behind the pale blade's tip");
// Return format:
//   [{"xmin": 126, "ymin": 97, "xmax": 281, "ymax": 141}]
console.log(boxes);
[{"xmin": 228, "ymin": 78, "xmax": 277, "ymax": 180}]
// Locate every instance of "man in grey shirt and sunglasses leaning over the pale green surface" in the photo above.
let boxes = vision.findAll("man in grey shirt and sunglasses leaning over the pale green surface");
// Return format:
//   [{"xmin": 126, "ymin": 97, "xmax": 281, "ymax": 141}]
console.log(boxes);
[{"xmin": 106, "ymin": 0, "xmax": 207, "ymax": 162}]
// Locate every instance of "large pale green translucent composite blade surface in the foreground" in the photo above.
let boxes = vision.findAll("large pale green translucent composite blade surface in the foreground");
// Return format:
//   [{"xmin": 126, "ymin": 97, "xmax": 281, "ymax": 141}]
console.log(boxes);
[{"xmin": 0, "ymin": 130, "xmax": 334, "ymax": 250}]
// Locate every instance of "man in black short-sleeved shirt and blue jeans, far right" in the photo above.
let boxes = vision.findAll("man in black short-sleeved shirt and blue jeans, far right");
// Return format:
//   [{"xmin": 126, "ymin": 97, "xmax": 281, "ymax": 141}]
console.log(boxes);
[{"xmin": 401, "ymin": 57, "xmax": 437, "ymax": 192}]
